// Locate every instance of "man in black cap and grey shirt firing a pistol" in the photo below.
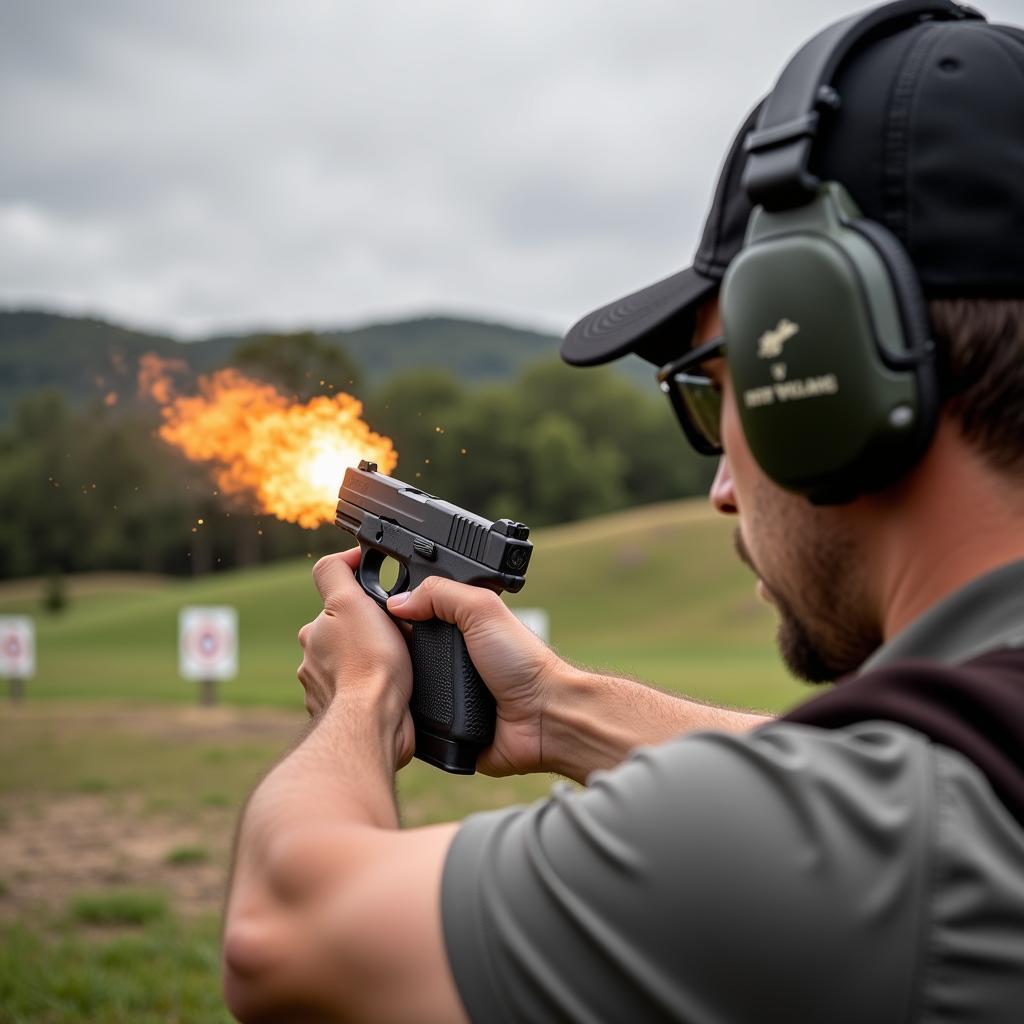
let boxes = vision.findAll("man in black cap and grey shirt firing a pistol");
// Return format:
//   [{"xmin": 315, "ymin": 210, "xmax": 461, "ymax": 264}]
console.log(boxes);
[{"xmin": 225, "ymin": 0, "xmax": 1024, "ymax": 1022}]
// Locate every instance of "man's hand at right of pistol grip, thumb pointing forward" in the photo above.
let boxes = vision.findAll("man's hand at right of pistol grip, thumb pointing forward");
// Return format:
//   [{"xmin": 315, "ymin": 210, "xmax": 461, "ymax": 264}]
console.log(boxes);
[{"xmin": 388, "ymin": 577, "xmax": 572, "ymax": 775}]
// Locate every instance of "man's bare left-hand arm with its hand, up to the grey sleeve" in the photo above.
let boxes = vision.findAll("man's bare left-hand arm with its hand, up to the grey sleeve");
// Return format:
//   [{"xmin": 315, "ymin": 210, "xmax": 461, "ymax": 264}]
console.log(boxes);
[{"xmin": 224, "ymin": 556, "xmax": 465, "ymax": 1022}]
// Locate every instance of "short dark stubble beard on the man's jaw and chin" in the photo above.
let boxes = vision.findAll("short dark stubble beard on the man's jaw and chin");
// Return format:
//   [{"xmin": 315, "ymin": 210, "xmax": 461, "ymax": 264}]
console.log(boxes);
[{"xmin": 734, "ymin": 528, "xmax": 882, "ymax": 683}]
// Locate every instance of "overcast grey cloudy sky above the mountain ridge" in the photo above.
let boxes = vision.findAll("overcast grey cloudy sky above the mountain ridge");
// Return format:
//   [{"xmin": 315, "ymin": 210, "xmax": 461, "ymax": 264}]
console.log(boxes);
[{"xmin": 0, "ymin": 0, "xmax": 1024, "ymax": 337}]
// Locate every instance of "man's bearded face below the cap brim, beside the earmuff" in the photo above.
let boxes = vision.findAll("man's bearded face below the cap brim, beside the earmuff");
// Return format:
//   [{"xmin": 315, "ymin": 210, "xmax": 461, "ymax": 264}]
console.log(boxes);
[{"xmin": 694, "ymin": 300, "xmax": 882, "ymax": 682}]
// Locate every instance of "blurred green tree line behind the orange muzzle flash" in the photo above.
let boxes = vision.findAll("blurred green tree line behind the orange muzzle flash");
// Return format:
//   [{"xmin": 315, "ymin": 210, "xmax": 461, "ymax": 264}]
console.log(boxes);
[{"xmin": 0, "ymin": 334, "xmax": 714, "ymax": 579}]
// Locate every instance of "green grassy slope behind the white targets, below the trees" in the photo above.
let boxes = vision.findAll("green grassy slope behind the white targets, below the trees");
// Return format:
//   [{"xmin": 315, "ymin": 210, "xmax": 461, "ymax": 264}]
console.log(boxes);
[{"xmin": 0, "ymin": 502, "xmax": 801, "ymax": 709}]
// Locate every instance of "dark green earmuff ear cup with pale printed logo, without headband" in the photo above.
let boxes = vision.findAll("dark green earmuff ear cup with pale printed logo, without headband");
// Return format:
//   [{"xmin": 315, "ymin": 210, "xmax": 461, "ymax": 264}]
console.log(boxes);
[{"xmin": 721, "ymin": 182, "xmax": 934, "ymax": 504}]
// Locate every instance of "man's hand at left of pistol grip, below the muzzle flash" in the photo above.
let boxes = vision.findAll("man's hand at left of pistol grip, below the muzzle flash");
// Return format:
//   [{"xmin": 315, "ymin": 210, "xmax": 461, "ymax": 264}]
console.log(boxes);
[{"xmin": 298, "ymin": 548, "xmax": 414, "ymax": 766}]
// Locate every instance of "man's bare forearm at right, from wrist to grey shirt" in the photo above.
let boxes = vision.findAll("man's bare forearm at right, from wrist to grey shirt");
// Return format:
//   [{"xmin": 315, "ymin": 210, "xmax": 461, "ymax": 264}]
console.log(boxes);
[{"xmin": 542, "ymin": 667, "xmax": 769, "ymax": 782}]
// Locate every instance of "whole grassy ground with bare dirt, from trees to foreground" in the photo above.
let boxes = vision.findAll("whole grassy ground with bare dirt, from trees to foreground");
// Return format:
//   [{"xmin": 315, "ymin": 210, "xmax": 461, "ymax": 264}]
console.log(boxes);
[{"xmin": 0, "ymin": 503, "xmax": 805, "ymax": 1024}]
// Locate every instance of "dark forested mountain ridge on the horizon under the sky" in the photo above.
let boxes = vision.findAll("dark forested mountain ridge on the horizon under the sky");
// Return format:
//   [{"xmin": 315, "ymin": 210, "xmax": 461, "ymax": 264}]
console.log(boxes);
[{"xmin": 0, "ymin": 309, "xmax": 558, "ymax": 421}]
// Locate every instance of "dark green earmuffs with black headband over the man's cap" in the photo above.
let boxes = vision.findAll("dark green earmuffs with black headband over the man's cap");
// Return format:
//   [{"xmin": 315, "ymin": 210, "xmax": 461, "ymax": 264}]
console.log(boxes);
[{"xmin": 721, "ymin": 0, "xmax": 981, "ymax": 504}]
